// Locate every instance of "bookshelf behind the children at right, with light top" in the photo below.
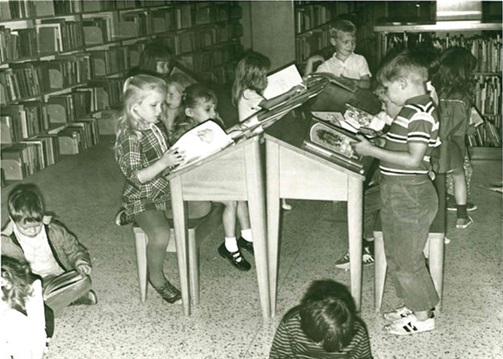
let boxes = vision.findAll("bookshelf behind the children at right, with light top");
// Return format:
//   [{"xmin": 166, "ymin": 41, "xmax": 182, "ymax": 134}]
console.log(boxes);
[{"xmin": 374, "ymin": 21, "xmax": 502, "ymax": 160}]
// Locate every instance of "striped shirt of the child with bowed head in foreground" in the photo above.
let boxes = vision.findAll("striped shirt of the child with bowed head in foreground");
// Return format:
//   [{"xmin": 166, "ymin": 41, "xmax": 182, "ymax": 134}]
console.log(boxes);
[{"xmin": 269, "ymin": 306, "xmax": 372, "ymax": 359}]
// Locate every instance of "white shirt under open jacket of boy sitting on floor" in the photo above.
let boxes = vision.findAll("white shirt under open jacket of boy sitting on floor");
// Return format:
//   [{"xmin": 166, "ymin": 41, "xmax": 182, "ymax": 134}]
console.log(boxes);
[{"xmin": 14, "ymin": 225, "xmax": 64, "ymax": 278}]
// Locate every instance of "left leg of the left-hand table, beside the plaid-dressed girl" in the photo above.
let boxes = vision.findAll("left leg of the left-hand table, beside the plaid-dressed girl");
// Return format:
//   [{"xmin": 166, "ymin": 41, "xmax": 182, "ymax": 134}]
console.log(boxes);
[{"xmin": 170, "ymin": 177, "xmax": 191, "ymax": 315}]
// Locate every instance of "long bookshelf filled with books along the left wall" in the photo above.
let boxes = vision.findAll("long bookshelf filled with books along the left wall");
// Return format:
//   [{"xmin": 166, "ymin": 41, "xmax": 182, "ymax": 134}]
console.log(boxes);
[{"xmin": 0, "ymin": 0, "xmax": 243, "ymax": 184}]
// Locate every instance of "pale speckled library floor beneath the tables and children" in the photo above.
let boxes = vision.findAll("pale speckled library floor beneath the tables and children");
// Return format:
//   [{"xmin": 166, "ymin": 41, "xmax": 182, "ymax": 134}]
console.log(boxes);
[{"xmin": 2, "ymin": 140, "xmax": 503, "ymax": 359}]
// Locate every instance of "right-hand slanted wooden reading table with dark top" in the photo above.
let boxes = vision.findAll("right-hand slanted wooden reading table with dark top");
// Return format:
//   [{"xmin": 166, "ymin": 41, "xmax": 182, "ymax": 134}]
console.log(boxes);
[{"xmin": 264, "ymin": 87, "xmax": 380, "ymax": 315}]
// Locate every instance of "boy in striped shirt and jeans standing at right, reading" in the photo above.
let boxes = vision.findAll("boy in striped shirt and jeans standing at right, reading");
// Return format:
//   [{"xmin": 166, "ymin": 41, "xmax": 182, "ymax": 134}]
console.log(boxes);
[{"xmin": 353, "ymin": 51, "xmax": 439, "ymax": 335}]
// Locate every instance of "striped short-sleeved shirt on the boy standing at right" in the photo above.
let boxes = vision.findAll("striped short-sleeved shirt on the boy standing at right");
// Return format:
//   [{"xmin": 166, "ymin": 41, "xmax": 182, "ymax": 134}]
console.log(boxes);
[{"xmin": 380, "ymin": 95, "xmax": 440, "ymax": 176}]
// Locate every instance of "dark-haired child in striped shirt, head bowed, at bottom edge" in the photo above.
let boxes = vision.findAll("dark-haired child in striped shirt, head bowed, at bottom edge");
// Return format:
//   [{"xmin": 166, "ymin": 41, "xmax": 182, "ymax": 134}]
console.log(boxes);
[{"xmin": 269, "ymin": 280, "xmax": 372, "ymax": 359}]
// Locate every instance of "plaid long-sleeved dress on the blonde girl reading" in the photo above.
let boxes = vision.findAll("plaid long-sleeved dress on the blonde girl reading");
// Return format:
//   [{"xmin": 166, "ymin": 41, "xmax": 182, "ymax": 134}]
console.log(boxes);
[{"xmin": 115, "ymin": 124, "xmax": 171, "ymax": 219}]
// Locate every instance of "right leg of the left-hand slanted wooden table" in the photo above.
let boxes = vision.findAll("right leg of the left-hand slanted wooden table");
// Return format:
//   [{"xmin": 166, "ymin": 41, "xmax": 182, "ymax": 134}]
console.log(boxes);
[{"xmin": 244, "ymin": 141, "xmax": 271, "ymax": 319}]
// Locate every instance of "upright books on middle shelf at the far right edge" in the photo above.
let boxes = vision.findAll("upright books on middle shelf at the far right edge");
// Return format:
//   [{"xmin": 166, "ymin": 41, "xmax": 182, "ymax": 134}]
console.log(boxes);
[{"xmin": 474, "ymin": 74, "xmax": 503, "ymax": 115}]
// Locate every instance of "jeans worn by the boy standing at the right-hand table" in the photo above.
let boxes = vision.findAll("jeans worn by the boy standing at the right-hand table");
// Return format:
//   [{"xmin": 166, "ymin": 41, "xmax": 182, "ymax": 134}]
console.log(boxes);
[{"xmin": 381, "ymin": 176, "xmax": 439, "ymax": 311}]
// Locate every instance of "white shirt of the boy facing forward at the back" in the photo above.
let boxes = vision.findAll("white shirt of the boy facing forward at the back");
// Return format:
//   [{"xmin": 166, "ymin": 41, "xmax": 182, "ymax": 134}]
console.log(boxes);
[{"xmin": 316, "ymin": 53, "xmax": 372, "ymax": 80}]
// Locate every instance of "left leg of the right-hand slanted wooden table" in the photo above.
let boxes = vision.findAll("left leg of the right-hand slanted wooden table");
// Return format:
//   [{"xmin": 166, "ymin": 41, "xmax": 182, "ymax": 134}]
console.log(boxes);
[{"xmin": 266, "ymin": 141, "xmax": 280, "ymax": 317}]
